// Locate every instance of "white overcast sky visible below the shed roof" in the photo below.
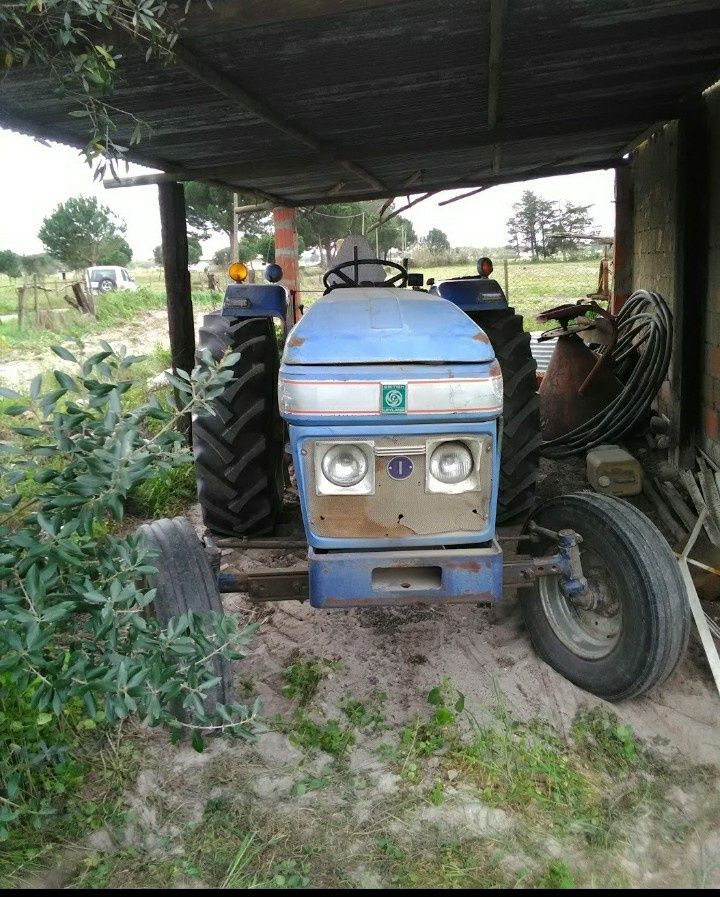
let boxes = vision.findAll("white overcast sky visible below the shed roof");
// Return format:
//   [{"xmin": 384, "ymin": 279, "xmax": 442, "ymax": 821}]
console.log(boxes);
[{"xmin": 0, "ymin": 129, "xmax": 614, "ymax": 261}]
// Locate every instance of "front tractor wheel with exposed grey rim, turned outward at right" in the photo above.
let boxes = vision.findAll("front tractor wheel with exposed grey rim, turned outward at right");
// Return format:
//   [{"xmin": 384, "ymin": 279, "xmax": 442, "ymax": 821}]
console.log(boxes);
[{"xmin": 520, "ymin": 492, "xmax": 690, "ymax": 701}]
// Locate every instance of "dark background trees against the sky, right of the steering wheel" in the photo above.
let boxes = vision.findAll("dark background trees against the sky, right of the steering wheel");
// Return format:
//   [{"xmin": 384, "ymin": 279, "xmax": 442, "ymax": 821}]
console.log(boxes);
[{"xmin": 507, "ymin": 190, "xmax": 598, "ymax": 259}]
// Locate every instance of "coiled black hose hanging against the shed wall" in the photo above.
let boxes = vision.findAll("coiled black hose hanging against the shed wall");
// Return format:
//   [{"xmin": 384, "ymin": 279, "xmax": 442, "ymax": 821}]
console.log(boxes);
[{"xmin": 540, "ymin": 290, "xmax": 672, "ymax": 458}]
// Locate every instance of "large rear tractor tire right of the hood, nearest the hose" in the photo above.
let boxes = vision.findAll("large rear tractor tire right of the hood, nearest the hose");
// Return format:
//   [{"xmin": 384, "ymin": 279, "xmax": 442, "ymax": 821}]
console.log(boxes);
[{"xmin": 468, "ymin": 308, "xmax": 541, "ymax": 524}]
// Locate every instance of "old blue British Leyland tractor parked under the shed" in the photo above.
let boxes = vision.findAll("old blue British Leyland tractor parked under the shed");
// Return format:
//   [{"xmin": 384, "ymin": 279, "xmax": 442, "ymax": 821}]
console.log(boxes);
[{"xmin": 139, "ymin": 240, "xmax": 689, "ymax": 712}]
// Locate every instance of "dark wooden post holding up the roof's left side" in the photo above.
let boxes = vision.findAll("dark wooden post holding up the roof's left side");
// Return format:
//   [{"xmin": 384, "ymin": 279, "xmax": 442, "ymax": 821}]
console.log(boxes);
[{"xmin": 158, "ymin": 183, "xmax": 195, "ymax": 372}]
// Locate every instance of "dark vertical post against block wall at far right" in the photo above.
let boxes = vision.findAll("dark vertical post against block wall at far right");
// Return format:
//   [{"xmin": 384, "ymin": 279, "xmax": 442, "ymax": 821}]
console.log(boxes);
[{"xmin": 670, "ymin": 96, "xmax": 710, "ymax": 468}]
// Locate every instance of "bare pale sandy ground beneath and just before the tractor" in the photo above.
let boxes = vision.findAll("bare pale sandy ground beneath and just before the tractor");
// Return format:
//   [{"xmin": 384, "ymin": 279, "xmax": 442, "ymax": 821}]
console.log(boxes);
[{"xmin": 224, "ymin": 512, "xmax": 720, "ymax": 765}]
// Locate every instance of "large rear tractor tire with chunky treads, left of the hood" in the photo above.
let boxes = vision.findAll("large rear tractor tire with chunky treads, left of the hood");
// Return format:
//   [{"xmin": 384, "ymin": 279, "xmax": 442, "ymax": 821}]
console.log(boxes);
[{"xmin": 193, "ymin": 313, "xmax": 284, "ymax": 536}]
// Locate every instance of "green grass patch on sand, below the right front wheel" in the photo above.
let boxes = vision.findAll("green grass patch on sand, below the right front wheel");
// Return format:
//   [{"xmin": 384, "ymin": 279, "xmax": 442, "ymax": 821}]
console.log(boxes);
[{"xmin": 385, "ymin": 684, "xmax": 661, "ymax": 848}]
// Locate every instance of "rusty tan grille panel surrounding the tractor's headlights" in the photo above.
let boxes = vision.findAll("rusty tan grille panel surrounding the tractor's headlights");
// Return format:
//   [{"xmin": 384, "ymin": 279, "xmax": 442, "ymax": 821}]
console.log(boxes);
[{"xmin": 303, "ymin": 434, "xmax": 492, "ymax": 540}]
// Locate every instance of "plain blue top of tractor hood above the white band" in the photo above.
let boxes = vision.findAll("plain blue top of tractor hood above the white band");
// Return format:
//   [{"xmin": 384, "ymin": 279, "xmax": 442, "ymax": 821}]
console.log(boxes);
[{"xmin": 283, "ymin": 287, "xmax": 495, "ymax": 365}]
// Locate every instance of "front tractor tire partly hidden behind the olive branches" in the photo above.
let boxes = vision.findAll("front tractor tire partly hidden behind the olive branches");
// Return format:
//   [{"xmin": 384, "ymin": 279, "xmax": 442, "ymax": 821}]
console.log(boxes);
[{"xmin": 138, "ymin": 517, "xmax": 233, "ymax": 711}]
